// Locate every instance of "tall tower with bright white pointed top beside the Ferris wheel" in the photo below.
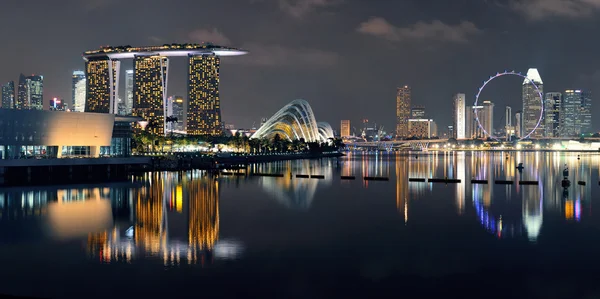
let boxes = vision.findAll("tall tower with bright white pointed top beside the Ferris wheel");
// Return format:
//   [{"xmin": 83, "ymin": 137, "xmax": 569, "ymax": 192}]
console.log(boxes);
[{"xmin": 521, "ymin": 68, "xmax": 544, "ymax": 138}]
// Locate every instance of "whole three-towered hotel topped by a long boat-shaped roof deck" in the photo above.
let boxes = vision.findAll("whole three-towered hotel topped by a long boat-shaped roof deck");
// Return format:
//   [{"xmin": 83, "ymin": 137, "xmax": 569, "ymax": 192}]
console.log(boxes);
[{"xmin": 83, "ymin": 43, "xmax": 247, "ymax": 135}]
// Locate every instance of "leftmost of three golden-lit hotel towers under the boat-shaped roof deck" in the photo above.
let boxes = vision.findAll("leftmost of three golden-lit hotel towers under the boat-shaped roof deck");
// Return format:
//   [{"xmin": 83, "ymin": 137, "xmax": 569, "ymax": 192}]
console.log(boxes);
[{"xmin": 85, "ymin": 56, "xmax": 121, "ymax": 114}]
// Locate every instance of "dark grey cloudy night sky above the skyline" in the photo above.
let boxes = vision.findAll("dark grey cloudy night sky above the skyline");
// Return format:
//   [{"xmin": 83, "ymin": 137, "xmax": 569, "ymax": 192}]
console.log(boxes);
[{"xmin": 0, "ymin": 0, "xmax": 600, "ymax": 131}]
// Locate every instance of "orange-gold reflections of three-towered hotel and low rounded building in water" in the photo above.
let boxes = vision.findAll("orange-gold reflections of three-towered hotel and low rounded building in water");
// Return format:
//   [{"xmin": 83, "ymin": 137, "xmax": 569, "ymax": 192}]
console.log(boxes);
[{"xmin": 0, "ymin": 171, "xmax": 242, "ymax": 266}]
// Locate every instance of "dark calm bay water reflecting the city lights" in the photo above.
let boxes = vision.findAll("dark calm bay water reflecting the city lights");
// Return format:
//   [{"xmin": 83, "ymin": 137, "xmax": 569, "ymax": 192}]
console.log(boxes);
[{"xmin": 0, "ymin": 152, "xmax": 600, "ymax": 298}]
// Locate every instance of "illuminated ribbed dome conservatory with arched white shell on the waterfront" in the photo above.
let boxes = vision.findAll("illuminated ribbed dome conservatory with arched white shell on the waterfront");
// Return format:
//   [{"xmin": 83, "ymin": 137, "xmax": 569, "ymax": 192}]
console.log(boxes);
[{"xmin": 251, "ymin": 100, "xmax": 333, "ymax": 142}]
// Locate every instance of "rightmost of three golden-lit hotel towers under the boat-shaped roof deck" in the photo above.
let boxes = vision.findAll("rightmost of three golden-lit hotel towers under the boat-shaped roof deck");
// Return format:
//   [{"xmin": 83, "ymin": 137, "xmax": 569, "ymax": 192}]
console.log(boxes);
[{"xmin": 186, "ymin": 55, "xmax": 223, "ymax": 136}]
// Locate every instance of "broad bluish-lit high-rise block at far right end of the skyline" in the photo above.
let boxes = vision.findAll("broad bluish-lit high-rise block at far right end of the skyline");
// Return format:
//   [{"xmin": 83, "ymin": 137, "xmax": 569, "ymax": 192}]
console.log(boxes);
[{"xmin": 560, "ymin": 90, "xmax": 592, "ymax": 137}]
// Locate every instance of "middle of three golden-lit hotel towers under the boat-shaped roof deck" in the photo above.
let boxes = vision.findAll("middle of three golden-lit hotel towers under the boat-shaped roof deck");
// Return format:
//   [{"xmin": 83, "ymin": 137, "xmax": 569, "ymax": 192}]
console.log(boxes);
[{"xmin": 132, "ymin": 55, "xmax": 169, "ymax": 135}]
